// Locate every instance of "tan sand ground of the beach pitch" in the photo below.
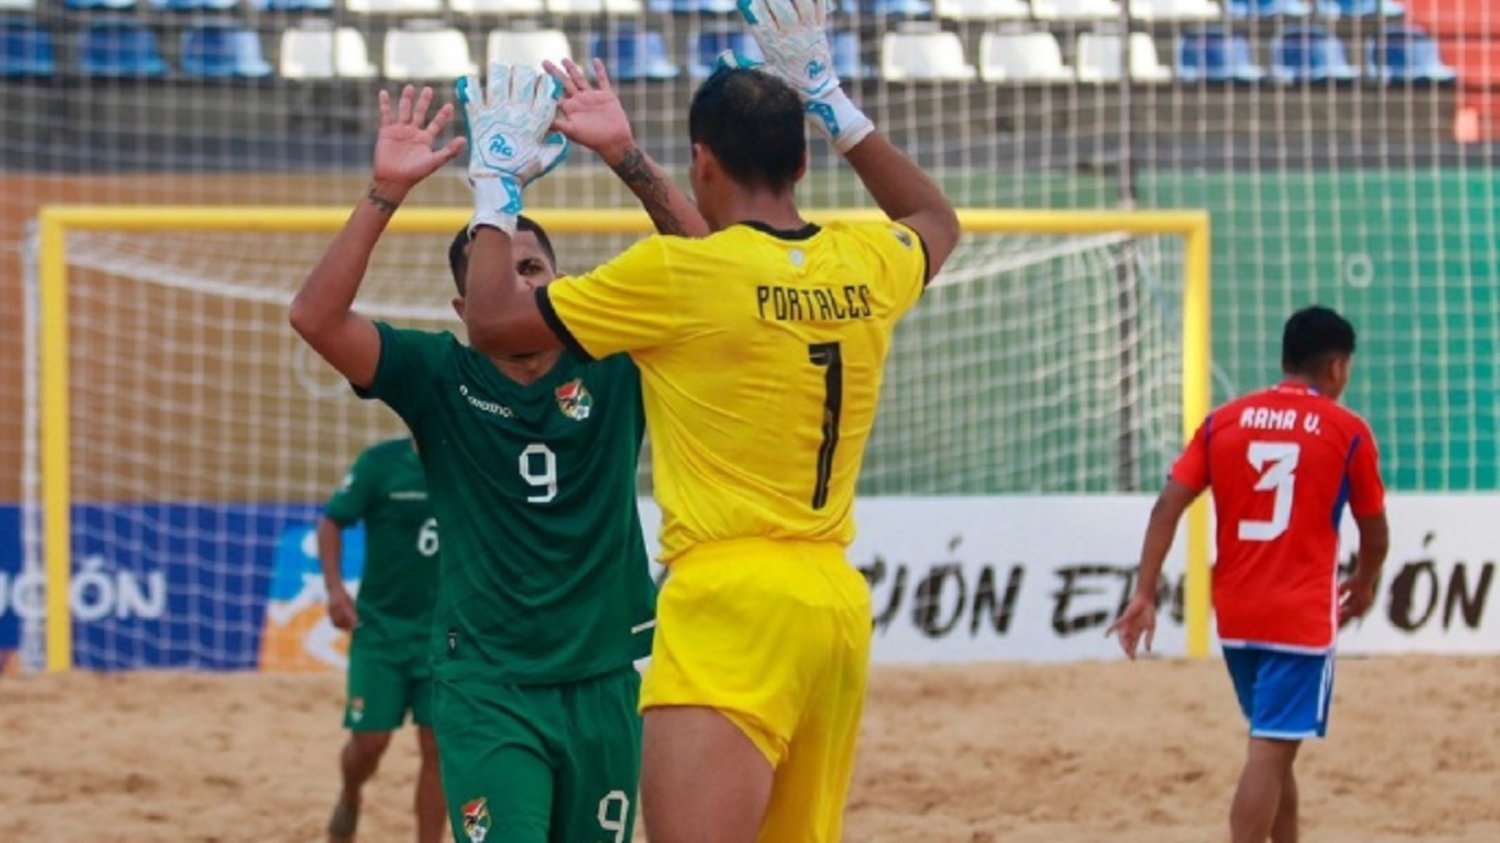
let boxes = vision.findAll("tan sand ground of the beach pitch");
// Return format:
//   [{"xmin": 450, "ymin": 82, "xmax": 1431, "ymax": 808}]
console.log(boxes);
[{"xmin": 0, "ymin": 657, "xmax": 1500, "ymax": 843}]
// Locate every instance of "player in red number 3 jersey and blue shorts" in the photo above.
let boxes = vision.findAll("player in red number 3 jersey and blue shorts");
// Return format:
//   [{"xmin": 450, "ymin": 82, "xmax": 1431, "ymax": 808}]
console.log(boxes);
[{"xmin": 1110, "ymin": 308, "xmax": 1389, "ymax": 843}]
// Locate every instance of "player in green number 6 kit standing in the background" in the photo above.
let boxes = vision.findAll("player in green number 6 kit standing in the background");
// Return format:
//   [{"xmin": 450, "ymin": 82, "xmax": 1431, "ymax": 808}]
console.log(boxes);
[{"xmin": 318, "ymin": 438, "xmax": 444, "ymax": 843}]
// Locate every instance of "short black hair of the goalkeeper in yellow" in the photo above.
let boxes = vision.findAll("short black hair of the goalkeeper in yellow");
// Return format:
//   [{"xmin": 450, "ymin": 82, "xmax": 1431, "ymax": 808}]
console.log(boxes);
[{"xmin": 687, "ymin": 68, "xmax": 807, "ymax": 192}]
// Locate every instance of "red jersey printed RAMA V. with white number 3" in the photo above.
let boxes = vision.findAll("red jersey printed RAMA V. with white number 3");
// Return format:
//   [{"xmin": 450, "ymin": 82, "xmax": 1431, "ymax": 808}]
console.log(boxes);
[{"xmin": 1172, "ymin": 383, "xmax": 1386, "ymax": 653}]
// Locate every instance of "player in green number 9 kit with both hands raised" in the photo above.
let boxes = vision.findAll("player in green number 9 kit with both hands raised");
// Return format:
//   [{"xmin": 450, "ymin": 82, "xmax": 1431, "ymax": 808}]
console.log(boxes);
[{"xmin": 291, "ymin": 73, "xmax": 707, "ymax": 843}]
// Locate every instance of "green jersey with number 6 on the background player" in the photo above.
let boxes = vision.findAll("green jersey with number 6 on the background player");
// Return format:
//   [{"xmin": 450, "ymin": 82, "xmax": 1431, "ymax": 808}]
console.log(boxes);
[{"xmin": 323, "ymin": 438, "xmax": 438, "ymax": 645}]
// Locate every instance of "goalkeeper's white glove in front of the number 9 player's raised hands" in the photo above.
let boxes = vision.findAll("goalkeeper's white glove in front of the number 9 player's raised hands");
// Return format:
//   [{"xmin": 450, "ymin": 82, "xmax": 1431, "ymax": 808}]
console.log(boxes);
[{"xmin": 455, "ymin": 62, "xmax": 569, "ymax": 234}]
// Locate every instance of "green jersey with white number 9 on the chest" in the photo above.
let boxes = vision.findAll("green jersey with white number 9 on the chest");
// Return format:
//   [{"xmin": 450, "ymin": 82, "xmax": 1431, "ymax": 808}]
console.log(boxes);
[{"xmin": 363, "ymin": 324, "xmax": 656, "ymax": 684}]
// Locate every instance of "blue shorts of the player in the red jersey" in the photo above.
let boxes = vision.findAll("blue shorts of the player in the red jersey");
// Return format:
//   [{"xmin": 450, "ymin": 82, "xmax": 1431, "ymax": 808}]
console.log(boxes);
[{"xmin": 1224, "ymin": 647, "xmax": 1334, "ymax": 741}]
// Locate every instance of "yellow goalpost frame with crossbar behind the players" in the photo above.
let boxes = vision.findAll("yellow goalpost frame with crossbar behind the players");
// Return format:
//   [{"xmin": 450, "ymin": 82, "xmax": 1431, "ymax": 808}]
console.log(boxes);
[{"xmin": 38, "ymin": 206, "xmax": 1211, "ymax": 671}]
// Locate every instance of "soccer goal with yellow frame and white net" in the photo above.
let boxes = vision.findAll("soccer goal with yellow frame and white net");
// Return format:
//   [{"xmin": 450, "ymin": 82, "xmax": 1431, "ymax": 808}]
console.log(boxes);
[{"xmin": 23, "ymin": 206, "xmax": 1211, "ymax": 671}]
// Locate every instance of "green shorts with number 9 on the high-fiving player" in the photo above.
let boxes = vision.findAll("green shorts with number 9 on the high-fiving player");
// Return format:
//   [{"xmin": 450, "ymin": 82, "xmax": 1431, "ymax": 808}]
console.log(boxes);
[{"xmin": 435, "ymin": 666, "xmax": 641, "ymax": 843}]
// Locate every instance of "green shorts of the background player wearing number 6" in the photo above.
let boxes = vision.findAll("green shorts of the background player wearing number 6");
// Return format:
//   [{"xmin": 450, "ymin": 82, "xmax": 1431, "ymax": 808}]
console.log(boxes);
[{"xmin": 344, "ymin": 638, "xmax": 432, "ymax": 732}]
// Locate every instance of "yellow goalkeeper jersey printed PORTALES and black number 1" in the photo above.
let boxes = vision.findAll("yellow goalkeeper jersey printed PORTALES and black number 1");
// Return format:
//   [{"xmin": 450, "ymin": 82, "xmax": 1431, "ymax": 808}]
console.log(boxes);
[{"xmin": 537, "ymin": 222, "xmax": 927, "ymax": 563}]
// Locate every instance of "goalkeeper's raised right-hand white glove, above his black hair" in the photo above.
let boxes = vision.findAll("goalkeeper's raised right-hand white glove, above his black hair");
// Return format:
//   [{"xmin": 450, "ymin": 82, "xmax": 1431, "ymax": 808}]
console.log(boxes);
[{"xmin": 738, "ymin": 0, "xmax": 875, "ymax": 155}]
